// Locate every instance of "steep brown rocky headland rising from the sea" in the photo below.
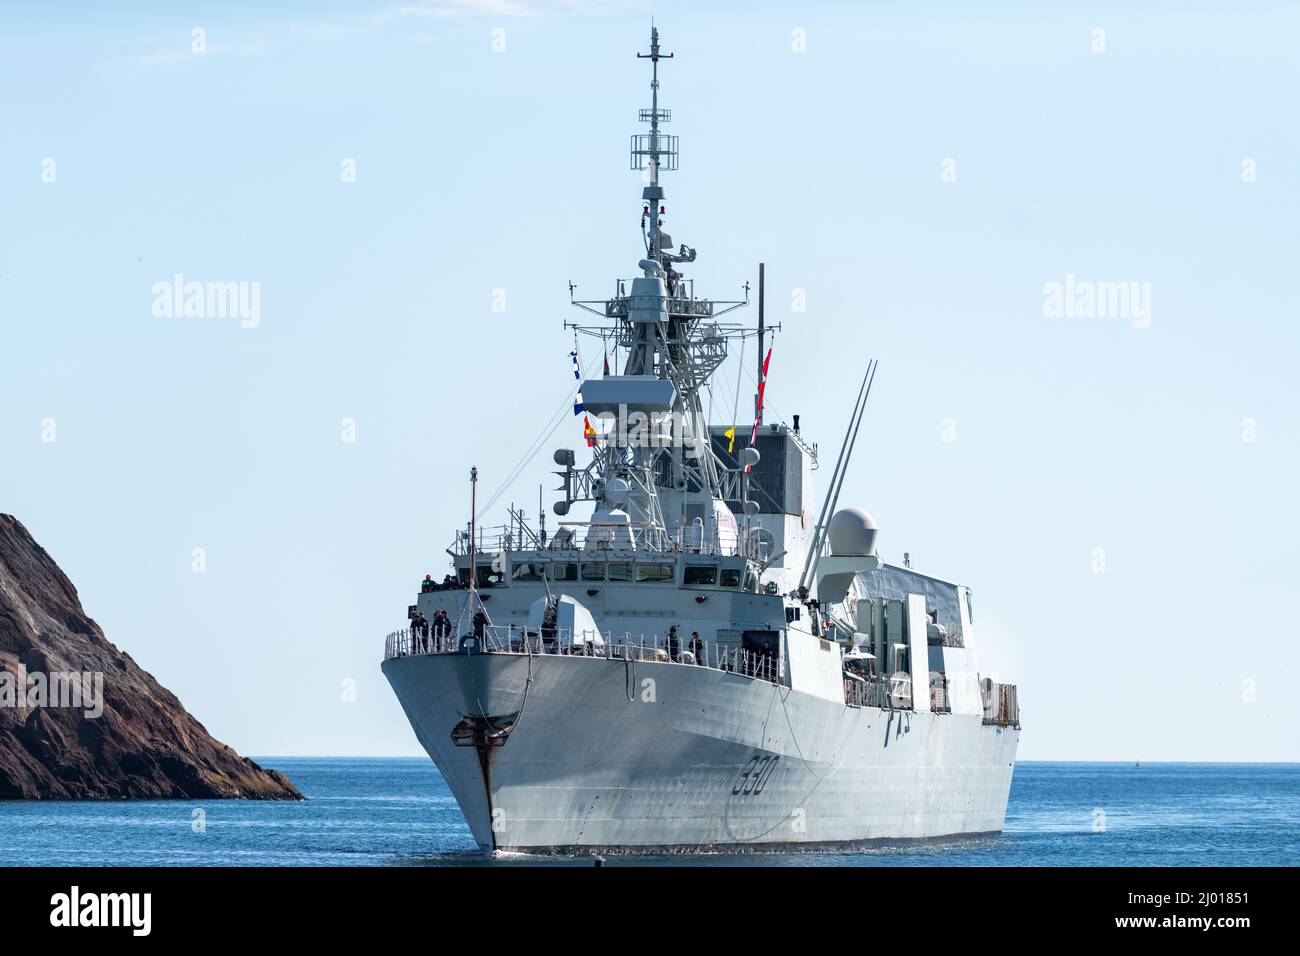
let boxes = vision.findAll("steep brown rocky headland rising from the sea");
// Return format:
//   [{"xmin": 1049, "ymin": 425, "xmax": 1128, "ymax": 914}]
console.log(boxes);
[{"xmin": 0, "ymin": 514, "xmax": 302, "ymax": 800}]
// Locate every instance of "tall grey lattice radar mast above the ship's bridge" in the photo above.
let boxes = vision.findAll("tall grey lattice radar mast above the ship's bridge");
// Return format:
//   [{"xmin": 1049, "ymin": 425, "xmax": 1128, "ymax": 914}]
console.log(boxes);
[{"xmin": 555, "ymin": 25, "xmax": 779, "ymax": 546}]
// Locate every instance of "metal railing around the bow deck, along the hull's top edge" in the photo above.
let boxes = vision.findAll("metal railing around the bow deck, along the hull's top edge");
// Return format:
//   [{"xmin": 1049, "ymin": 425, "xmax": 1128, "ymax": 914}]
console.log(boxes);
[{"xmin": 384, "ymin": 624, "xmax": 789, "ymax": 684}]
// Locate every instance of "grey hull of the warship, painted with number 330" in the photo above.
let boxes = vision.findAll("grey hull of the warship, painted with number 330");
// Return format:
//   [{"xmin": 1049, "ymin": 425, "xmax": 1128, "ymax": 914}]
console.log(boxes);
[{"xmin": 384, "ymin": 653, "xmax": 1019, "ymax": 852}]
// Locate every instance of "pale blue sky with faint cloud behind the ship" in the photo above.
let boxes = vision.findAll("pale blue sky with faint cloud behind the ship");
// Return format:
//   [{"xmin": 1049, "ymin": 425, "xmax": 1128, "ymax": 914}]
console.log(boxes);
[{"xmin": 0, "ymin": 0, "xmax": 1300, "ymax": 760}]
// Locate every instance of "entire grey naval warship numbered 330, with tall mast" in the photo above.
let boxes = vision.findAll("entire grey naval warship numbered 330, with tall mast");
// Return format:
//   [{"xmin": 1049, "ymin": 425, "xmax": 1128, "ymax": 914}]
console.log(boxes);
[{"xmin": 382, "ymin": 30, "xmax": 1019, "ymax": 853}]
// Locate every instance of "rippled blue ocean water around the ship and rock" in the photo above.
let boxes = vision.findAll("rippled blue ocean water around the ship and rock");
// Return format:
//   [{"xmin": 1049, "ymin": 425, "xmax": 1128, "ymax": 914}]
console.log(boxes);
[{"xmin": 0, "ymin": 757, "xmax": 1300, "ymax": 866}]
